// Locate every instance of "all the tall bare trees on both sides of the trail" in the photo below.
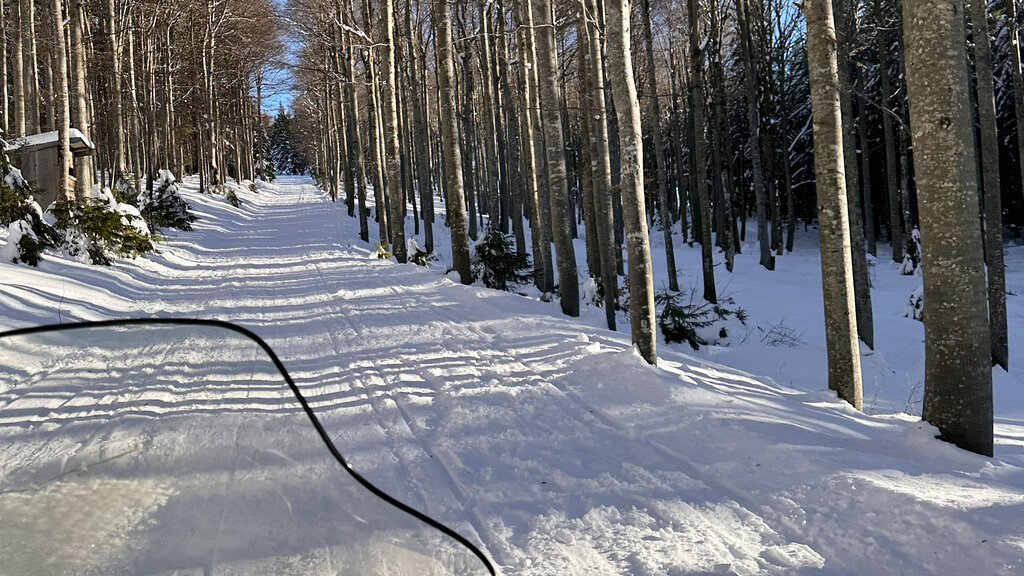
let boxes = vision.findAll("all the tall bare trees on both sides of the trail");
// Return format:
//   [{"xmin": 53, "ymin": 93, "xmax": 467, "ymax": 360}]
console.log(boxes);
[{"xmin": 0, "ymin": 0, "xmax": 1007, "ymax": 452}]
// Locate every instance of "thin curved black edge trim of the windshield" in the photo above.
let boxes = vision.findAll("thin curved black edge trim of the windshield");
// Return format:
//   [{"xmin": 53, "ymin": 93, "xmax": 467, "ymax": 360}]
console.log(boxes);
[{"xmin": 0, "ymin": 318, "xmax": 497, "ymax": 576}]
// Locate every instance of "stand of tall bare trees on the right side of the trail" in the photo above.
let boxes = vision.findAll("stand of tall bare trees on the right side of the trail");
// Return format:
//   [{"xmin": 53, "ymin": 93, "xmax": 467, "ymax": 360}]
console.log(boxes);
[{"xmin": 287, "ymin": 0, "xmax": 1011, "ymax": 452}]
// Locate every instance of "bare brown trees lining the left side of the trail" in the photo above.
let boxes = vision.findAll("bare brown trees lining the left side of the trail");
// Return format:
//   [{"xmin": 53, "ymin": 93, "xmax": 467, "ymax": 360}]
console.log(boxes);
[{"xmin": 0, "ymin": 0, "xmax": 282, "ymax": 197}]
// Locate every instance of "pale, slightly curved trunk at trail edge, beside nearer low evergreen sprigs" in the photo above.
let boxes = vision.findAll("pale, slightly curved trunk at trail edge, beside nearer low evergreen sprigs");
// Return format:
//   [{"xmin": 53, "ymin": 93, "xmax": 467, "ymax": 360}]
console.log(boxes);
[{"xmin": 607, "ymin": 0, "xmax": 657, "ymax": 364}]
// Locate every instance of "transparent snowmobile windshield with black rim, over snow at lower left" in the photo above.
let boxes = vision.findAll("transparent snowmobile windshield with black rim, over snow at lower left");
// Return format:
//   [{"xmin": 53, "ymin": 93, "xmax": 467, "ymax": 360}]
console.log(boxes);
[{"xmin": 0, "ymin": 321, "xmax": 493, "ymax": 576}]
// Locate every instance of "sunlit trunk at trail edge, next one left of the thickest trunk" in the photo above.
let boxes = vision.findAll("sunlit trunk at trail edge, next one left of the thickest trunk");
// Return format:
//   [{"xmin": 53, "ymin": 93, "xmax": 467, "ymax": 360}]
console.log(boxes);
[{"xmin": 803, "ymin": 0, "xmax": 860, "ymax": 410}]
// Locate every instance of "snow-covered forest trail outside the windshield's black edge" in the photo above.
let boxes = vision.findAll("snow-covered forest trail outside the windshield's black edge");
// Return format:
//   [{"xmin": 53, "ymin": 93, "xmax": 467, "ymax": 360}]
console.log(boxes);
[{"xmin": 0, "ymin": 179, "xmax": 1024, "ymax": 575}]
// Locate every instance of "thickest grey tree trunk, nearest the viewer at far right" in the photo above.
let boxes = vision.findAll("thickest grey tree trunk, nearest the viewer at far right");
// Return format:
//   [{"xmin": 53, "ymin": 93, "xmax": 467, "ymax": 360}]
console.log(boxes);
[{"xmin": 903, "ymin": 0, "xmax": 992, "ymax": 456}]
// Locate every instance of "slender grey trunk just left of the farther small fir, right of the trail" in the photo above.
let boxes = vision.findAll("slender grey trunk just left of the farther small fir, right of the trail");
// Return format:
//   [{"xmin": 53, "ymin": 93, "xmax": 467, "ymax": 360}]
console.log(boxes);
[{"xmin": 433, "ymin": 0, "xmax": 473, "ymax": 284}]
